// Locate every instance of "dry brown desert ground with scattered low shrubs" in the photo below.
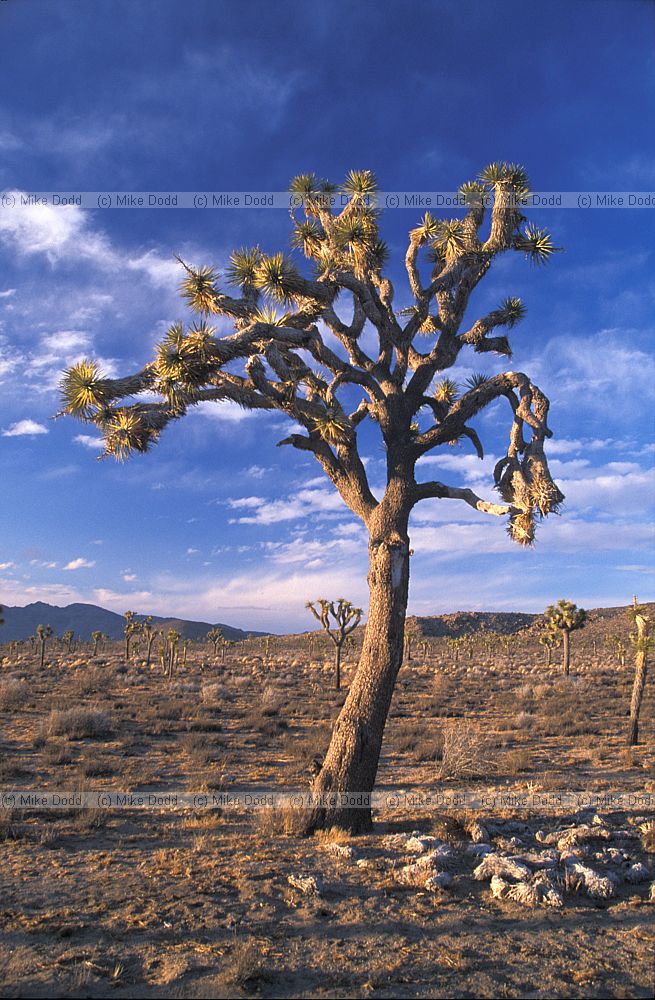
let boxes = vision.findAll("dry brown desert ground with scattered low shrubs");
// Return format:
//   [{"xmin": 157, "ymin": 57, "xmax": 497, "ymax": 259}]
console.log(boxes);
[{"xmin": 0, "ymin": 608, "xmax": 655, "ymax": 998}]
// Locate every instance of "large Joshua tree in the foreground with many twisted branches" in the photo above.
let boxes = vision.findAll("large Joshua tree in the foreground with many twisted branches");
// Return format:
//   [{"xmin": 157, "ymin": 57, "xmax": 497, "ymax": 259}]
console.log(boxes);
[{"xmin": 62, "ymin": 163, "xmax": 564, "ymax": 831}]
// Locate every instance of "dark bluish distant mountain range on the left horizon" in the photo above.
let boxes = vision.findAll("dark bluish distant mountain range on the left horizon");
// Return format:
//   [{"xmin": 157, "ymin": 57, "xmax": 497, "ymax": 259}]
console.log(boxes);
[{"xmin": 0, "ymin": 601, "xmax": 269, "ymax": 642}]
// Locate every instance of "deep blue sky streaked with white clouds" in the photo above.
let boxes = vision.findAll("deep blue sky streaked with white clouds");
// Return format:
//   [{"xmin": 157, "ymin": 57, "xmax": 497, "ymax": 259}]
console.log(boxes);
[{"xmin": 0, "ymin": 0, "xmax": 655, "ymax": 631}]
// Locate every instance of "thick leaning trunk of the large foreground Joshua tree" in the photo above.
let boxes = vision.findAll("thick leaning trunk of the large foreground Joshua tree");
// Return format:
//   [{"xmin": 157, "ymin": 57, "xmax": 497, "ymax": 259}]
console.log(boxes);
[{"xmin": 306, "ymin": 518, "xmax": 409, "ymax": 833}]
